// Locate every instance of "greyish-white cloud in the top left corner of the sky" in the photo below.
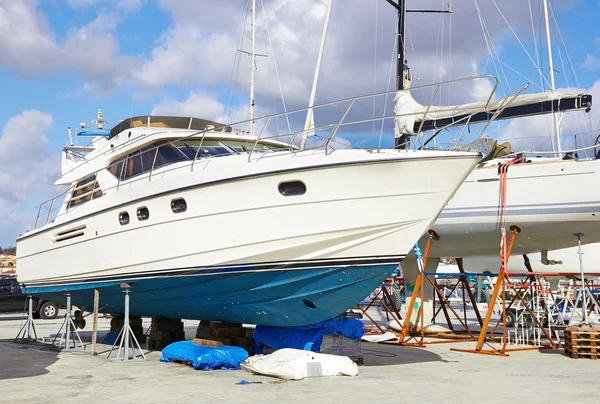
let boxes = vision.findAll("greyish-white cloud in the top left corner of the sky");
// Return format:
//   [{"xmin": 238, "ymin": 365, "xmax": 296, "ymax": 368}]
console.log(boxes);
[{"xmin": 0, "ymin": 0, "xmax": 139, "ymax": 90}]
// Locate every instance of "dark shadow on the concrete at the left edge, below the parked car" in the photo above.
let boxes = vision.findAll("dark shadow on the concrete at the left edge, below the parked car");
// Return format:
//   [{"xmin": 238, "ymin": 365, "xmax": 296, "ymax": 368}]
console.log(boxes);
[{"xmin": 0, "ymin": 342, "xmax": 58, "ymax": 380}]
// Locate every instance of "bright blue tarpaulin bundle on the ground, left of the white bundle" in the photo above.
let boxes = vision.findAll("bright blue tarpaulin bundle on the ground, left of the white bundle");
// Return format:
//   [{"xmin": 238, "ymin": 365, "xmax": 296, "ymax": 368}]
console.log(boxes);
[{"xmin": 160, "ymin": 341, "xmax": 248, "ymax": 370}]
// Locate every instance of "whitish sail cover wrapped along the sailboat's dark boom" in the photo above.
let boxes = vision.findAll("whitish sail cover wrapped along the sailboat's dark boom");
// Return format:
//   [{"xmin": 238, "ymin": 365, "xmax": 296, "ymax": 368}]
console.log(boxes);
[{"xmin": 394, "ymin": 90, "xmax": 592, "ymax": 137}]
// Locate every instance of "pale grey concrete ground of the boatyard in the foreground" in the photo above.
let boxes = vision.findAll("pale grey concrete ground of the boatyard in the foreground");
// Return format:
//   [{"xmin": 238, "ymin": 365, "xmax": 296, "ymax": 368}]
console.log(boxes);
[{"xmin": 0, "ymin": 315, "xmax": 600, "ymax": 404}]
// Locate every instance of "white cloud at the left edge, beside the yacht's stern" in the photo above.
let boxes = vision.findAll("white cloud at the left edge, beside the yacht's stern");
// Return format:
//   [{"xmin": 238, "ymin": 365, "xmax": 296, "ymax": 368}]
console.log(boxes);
[{"xmin": 0, "ymin": 110, "xmax": 60, "ymax": 245}]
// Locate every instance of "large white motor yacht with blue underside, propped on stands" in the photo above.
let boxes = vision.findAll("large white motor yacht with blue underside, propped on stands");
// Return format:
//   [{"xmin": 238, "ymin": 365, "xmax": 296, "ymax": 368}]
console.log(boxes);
[{"xmin": 17, "ymin": 2, "xmax": 480, "ymax": 325}]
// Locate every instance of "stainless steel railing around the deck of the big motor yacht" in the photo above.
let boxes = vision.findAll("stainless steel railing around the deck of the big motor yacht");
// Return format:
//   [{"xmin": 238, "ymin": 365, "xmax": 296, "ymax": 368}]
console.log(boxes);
[{"xmin": 34, "ymin": 75, "xmax": 526, "ymax": 228}]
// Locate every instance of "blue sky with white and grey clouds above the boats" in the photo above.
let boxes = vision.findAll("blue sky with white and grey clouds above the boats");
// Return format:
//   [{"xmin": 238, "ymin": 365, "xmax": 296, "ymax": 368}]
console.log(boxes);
[{"xmin": 0, "ymin": 0, "xmax": 600, "ymax": 247}]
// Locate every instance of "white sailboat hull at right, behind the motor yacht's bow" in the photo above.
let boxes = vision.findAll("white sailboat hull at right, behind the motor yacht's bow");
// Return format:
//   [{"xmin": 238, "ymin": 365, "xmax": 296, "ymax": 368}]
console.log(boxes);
[{"xmin": 420, "ymin": 160, "xmax": 600, "ymax": 258}]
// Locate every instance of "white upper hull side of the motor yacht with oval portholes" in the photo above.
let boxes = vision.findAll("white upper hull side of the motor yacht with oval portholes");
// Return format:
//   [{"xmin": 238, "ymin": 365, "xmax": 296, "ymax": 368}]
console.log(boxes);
[{"xmin": 17, "ymin": 150, "xmax": 476, "ymax": 287}]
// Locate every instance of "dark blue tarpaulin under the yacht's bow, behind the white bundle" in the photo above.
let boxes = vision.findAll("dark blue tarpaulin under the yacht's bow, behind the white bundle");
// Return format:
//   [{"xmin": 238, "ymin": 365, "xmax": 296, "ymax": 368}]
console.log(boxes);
[{"xmin": 254, "ymin": 318, "xmax": 365, "ymax": 352}]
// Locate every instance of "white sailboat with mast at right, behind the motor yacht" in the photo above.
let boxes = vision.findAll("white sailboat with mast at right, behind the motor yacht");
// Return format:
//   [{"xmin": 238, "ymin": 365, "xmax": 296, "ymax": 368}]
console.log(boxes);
[{"xmin": 397, "ymin": 0, "xmax": 600, "ymax": 326}]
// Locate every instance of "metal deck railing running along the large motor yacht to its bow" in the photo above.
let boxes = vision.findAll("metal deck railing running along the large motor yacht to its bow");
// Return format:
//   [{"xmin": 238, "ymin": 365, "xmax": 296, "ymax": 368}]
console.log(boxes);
[{"xmin": 35, "ymin": 75, "xmax": 526, "ymax": 228}]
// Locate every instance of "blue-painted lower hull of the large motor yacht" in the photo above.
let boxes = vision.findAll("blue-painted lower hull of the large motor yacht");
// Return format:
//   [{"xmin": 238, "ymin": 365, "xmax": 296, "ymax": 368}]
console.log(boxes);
[{"xmin": 23, "ymin": 261, "xmax": 398, "ymax": 326}]
